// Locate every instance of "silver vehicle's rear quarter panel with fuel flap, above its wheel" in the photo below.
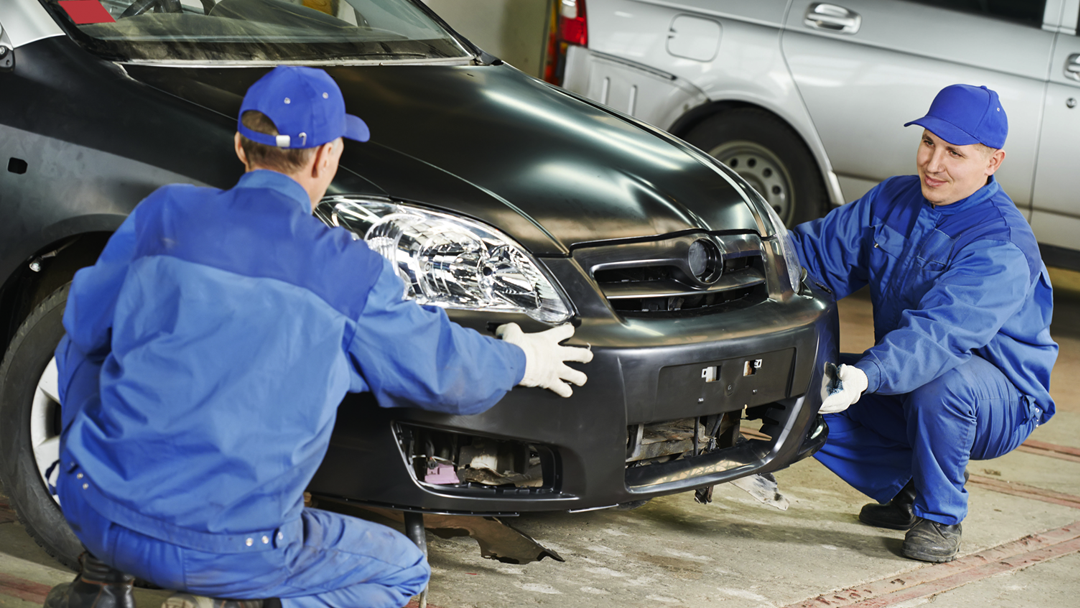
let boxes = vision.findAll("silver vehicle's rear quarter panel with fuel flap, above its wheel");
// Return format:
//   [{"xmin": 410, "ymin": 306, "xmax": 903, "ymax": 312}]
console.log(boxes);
[{"xmin": 564, "ymin": 0, "xmax": 845, "ymax": 205}]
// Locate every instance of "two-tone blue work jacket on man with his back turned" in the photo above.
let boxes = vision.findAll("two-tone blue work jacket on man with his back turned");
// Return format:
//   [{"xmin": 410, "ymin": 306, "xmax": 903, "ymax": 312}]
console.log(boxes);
[{"xmin": 56, "ymin": 171, "xmax": 525, "ymax": 551}]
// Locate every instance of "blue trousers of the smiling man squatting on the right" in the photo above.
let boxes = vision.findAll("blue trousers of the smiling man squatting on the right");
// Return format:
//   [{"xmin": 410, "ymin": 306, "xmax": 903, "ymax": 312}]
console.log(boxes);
[{"xmin": 815, "ymin": 354, "xmax": 1038, "ymax": 525}]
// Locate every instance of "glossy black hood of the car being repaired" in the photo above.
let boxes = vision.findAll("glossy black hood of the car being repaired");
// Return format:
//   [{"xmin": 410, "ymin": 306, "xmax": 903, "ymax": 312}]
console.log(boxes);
[{"xmin": 125, "ymin": 65, "xmax": 757, "ymax": 255}]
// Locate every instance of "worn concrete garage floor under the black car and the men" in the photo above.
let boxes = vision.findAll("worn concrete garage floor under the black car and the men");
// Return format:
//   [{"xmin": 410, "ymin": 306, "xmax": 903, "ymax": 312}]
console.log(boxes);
[{"xmin": 0, "ymin": 271, "xmax": 1080, "ymax": 608}]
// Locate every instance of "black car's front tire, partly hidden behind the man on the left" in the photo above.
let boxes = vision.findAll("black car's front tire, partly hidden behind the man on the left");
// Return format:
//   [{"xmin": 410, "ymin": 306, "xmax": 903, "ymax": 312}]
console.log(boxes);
[{"xmin": 0, "ymin": 283, "xmax": 83, "ymax": 570}]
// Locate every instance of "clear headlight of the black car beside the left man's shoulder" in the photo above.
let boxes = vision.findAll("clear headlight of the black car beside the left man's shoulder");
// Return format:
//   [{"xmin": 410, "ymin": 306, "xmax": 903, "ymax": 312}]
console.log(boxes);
[{"xmin": 315, "ymin": 197, "xmax": 571, "ymax": 324}]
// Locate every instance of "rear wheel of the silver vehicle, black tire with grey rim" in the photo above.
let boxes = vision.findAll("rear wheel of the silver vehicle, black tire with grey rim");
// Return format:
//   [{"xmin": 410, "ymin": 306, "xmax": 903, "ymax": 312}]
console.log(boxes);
[{"xmin": 684, "ymin": 108, "xmax": 828, "ymax": 227}]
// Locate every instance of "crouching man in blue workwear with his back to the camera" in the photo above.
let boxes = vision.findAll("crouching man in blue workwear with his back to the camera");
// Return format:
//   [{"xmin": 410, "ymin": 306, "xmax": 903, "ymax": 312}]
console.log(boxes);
[{"xmin": 46, "ymin": 67, "xmax": 592, "ymax": 608}]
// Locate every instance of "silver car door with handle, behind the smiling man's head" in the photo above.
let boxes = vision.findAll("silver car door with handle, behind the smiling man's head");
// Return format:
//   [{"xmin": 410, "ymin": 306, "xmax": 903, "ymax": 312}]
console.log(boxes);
[{"xmin": 782, "ymin": 0, "xmax": 1055, "ymax": 210}]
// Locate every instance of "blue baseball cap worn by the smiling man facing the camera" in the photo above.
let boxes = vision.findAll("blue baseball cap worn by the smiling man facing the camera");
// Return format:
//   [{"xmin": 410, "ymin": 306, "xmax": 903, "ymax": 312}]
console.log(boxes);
[{"xmin": 904, "ymin": 84, "xmax": 1009, "ymax": 148}]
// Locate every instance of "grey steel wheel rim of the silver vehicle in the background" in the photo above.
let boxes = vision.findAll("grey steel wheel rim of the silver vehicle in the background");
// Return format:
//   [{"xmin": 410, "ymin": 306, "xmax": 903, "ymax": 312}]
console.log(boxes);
[{"xmin": 708, "ymin": 141, "xmax": 795, "ymax": 226}]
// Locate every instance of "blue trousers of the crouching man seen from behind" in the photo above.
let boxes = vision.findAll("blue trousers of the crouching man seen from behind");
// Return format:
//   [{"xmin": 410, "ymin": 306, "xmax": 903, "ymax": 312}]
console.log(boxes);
[{"xmin": 58, "ymin": 473, "xmax": 431, "ymax": 608}]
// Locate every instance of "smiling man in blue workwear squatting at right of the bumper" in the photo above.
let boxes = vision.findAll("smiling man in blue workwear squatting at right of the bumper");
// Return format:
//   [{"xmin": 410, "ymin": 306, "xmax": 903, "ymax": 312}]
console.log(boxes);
[{"xmin": 793, "ymin": 84, "xmax": 1057, "ymax": 562}]
